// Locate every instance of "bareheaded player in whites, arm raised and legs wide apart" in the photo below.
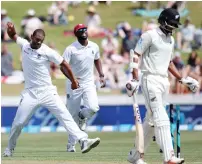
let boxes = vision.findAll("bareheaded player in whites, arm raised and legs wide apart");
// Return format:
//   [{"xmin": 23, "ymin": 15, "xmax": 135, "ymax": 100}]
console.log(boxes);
[{"xmin": 3, "ymin": 22, "xmax": 100, "ymax": 157}]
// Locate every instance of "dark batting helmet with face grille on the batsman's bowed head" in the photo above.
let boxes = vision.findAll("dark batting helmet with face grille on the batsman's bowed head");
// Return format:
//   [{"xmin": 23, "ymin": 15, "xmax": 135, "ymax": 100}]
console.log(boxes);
[{"xmin": 158, "ymin": 8, "xmax": 181, "ymax": 34}]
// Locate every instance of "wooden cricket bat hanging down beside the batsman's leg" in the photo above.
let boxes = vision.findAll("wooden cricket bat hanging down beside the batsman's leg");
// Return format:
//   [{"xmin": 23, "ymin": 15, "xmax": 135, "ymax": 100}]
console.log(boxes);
[{"xmin": 133, "ymin": 93, "xmax": 144, "ymax": 154}]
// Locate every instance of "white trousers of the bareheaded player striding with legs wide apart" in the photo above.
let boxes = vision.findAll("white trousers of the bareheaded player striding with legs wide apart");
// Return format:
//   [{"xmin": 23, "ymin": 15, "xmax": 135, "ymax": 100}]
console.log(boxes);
[{"xmin": 8, "ymin": 86, "xmax": 88, "ymax": 149}]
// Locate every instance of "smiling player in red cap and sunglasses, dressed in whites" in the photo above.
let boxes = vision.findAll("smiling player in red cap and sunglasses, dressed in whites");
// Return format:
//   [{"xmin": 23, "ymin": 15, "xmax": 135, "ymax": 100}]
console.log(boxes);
[{"xmin": 63, "ymin": 24, "xmax": 105, "ymax": 152}]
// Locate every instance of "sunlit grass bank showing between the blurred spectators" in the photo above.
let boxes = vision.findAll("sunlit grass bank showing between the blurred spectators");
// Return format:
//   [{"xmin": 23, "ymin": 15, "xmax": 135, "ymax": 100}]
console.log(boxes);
[{"xmin": 1, "ymin": 1, "xmax": 202, "ymax": 96}]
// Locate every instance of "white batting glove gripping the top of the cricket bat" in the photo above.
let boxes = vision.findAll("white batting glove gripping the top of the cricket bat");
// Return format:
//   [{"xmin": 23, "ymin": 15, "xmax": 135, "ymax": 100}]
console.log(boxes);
[{"xmin": 126, "ymin": 79, "xmax": 139, "ymax": 97}]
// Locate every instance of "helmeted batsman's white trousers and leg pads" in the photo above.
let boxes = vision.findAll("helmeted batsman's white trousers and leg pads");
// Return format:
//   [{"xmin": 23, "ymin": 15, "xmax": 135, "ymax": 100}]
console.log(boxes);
[{"xmin": 141, "ymin": 74, "xmax": 174, "ymax": 162}]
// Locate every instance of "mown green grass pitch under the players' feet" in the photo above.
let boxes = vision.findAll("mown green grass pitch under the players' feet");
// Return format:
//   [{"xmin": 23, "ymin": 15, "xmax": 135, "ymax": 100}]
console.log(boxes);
[{"xmin": 1, "ymin": 132, "xmax": 202, "ymax": 164}]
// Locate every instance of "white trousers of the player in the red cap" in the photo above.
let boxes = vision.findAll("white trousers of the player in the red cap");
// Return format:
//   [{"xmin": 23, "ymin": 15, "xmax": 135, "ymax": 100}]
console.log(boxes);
[{"xmin": 66, "ymin": 83, "xmax": 99, "ymax": 145}]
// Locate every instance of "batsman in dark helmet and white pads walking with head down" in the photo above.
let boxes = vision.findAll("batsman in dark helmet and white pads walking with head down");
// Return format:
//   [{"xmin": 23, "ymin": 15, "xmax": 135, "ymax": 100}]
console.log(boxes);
[{"xmin": 127, "ymin": 8, "xmax": 199, "ymax": 164}]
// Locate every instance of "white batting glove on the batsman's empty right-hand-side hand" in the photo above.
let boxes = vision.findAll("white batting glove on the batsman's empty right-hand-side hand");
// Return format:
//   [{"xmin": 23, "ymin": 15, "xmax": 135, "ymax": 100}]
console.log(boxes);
[{"xmin": 179, "ymin": 76, "xmax": 199, "ymax": 93}]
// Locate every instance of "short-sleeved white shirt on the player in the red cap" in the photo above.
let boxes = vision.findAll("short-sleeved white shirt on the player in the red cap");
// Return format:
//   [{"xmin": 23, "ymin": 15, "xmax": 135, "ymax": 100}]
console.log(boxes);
[{"xmin": 63, "ymin": 40, "xmax": 100, "ymax": 84}]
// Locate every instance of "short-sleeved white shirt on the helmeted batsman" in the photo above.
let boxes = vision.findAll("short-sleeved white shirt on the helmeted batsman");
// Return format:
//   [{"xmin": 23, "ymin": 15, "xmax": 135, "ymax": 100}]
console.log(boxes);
[{"xmin": 134, "ymin": 28, "xmax": 174, "ymax": 77}]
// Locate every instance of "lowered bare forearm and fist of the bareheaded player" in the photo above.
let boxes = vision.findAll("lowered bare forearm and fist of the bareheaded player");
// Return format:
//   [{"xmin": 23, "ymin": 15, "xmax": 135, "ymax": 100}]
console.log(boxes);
[{"xmin": 60, "ymin": 60, "xmax": 79, "ymax": 90}]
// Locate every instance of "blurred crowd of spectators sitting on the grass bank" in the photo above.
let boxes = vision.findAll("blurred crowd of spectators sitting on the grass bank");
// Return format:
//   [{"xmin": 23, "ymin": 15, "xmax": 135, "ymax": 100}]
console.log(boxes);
[{"xmin": 1, "ymin": 1, "xmax": 202, "ymax": 94}]
